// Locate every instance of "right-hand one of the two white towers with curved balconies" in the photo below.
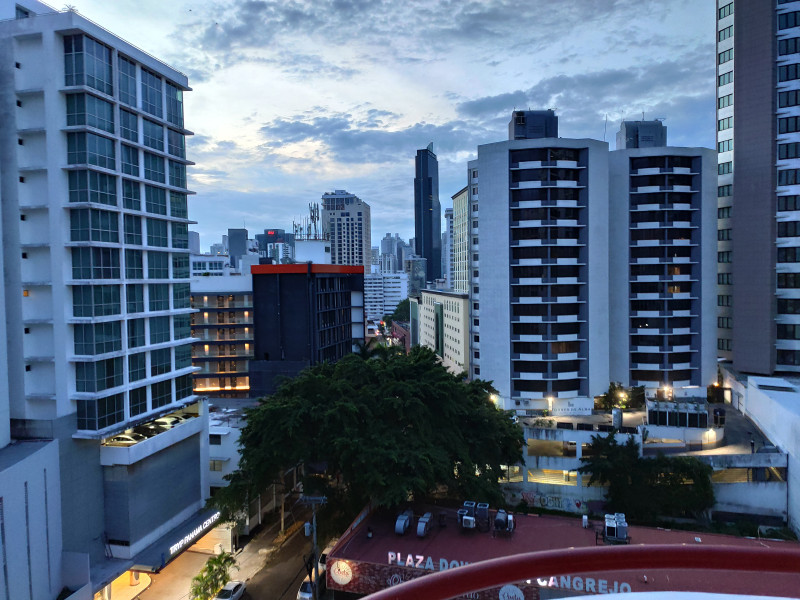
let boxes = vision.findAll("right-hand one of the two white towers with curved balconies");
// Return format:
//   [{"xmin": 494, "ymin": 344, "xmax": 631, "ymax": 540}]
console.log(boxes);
[{"xmin": 609, "ymin": 121, "xmax": 717, "ymax": 388}]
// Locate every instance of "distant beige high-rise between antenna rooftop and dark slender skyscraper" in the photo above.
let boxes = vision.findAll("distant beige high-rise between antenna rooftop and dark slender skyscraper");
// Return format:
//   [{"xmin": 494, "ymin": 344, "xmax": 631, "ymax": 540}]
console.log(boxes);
[{"xmin": 322, "ymin": 190, "xmax": 372, "ymax": 273}]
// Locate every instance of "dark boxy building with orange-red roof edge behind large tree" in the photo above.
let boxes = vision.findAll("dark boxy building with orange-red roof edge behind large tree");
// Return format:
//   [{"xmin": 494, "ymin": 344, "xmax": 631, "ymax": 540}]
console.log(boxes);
[{"xmin": 250, "ymin": 263, "xmax": 365, "ymax": 397}]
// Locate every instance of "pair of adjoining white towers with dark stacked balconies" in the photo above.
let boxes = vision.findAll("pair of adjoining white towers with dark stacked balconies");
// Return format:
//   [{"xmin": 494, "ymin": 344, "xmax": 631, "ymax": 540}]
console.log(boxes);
[{"xmin": 466, "ymin": 111, "xmax": 716, "ymax": 408}]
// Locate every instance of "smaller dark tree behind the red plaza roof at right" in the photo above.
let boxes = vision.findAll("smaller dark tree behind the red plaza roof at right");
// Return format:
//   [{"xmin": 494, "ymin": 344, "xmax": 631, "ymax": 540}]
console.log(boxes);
[{"xmin": 578, "ymin": 431, "xmax": 714, "ymax": 521}]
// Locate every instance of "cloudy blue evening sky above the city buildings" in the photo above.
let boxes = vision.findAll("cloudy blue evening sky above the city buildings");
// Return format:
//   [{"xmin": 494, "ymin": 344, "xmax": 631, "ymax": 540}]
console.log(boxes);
[{"xmin": 69, "ymin": 0, "xmax": 715, "ymax": 251}]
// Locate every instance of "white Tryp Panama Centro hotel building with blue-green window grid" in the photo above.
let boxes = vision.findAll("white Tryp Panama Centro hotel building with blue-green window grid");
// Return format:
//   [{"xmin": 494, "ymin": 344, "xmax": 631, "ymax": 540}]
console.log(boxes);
[{"xmin": 0, "ymin": 0, "xmax": 208, "ymax": 600}]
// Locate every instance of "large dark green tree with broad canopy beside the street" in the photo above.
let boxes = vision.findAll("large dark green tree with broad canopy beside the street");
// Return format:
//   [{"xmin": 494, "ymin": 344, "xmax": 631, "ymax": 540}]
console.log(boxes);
[{"xmin": 213, "ymin": 347, "xmax": 522, "ymax": 516}]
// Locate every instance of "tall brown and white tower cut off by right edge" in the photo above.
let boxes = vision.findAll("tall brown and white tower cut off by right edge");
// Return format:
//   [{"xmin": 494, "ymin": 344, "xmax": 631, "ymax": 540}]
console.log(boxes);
[{"xmin": 717, "ymin": 0, "xmax": 800, "ymax": 374}]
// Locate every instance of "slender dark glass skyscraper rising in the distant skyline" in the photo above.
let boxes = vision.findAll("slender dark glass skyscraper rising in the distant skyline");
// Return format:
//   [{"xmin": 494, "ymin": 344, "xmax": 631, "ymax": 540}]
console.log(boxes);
[{"xmin": 414, "ymin": 143, "xmax": 442, "ymax": 281}]
